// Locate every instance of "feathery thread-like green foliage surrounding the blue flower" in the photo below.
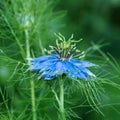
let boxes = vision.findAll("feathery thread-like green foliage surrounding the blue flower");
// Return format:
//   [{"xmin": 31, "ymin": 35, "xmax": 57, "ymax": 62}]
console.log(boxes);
[{"xmin": 0, "ymin": 0, "xmax": 120, "ymax": 120}]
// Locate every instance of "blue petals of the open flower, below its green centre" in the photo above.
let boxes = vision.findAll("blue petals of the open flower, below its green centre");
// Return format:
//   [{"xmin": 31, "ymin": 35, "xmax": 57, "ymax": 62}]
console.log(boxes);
[{"xmin": 29, "ymin": 54, "xmax": 96, "ymax": 80}]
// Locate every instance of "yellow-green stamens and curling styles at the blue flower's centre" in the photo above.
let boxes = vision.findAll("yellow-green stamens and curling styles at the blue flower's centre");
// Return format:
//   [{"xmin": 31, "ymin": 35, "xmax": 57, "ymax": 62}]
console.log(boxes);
[{"xmin": 45, "ymin": 33, "xmax": 85, "ymax": 61}]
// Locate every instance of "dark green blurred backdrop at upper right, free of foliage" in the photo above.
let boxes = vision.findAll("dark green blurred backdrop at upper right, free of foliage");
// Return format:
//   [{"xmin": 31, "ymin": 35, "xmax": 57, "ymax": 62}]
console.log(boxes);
[{"xmin": 56, "ymin": 0, "xmax": 120, "ymax": 59}]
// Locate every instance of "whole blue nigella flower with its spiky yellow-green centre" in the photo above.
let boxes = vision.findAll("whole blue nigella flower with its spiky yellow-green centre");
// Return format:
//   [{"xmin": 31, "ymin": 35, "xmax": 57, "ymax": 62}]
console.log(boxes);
[{"xmin": 29, "ymin": 34, "xmax": 96, "ymax": 80}]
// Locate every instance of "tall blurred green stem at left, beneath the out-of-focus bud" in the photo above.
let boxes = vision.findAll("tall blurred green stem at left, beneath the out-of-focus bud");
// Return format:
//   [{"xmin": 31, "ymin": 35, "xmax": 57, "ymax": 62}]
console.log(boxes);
[{"xmin": 25, "ymin": 30, "xmax": 37, "ymax": 120}]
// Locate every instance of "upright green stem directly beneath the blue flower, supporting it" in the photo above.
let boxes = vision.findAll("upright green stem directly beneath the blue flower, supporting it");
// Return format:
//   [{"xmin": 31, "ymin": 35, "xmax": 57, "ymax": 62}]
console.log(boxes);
[{"xmin": 59, "ymin": 81, "xmax": 66, "ymax": 120}]
